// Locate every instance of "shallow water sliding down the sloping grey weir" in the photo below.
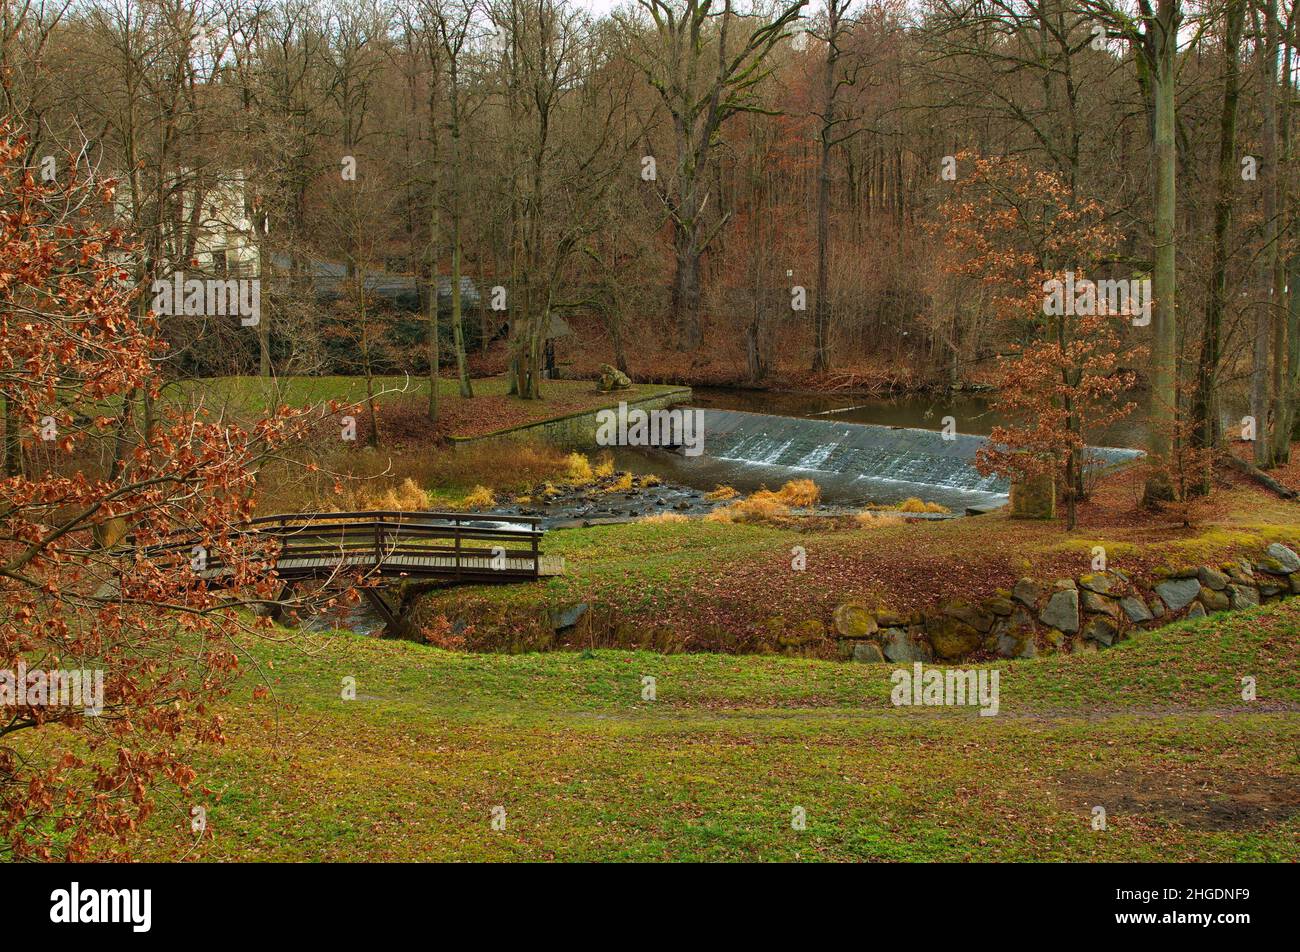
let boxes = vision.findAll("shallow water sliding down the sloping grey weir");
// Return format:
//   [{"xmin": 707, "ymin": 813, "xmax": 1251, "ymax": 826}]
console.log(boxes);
[{"xmin": 686, "ymin": 410, "xmax": 1141, "ymax": 511}]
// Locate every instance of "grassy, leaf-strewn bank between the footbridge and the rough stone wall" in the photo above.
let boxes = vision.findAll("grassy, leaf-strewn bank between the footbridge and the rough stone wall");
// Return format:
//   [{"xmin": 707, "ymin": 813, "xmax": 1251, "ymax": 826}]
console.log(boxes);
[{"xmin": 411, "ymin": 471, "xmax": 1300, "ymax": 658}]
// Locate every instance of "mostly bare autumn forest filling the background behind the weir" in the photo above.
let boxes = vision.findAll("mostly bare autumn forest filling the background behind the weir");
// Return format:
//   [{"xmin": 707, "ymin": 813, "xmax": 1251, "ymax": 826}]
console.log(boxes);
[{"xmin": 0, "ymin": 0, "xmax": 1300, "ymax": 476}]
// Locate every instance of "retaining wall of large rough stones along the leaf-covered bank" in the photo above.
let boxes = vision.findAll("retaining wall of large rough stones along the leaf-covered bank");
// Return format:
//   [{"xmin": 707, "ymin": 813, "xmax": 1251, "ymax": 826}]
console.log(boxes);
[{"xmin": 835, "ymin": 542, "xmax": 1300, "ymax": 662}]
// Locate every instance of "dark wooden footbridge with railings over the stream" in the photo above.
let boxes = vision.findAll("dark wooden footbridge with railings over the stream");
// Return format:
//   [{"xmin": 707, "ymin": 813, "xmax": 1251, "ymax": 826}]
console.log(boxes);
[{"xmin": 134, "ymin": 510, "xmax": 564, "ymax": 633}]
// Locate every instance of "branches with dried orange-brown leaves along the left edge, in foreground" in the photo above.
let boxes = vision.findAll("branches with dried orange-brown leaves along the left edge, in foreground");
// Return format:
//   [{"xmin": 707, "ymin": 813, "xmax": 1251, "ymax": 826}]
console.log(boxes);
[{"xmin": 0, "ymin": 124, "xmax": 314, "ymax": 860}]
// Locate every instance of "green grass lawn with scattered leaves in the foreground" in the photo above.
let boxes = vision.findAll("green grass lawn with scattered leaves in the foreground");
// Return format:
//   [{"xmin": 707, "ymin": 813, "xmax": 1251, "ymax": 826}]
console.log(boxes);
[{"xmin": 101, "ymin": 603, "xmax": 1300, "ymax": 861}]
